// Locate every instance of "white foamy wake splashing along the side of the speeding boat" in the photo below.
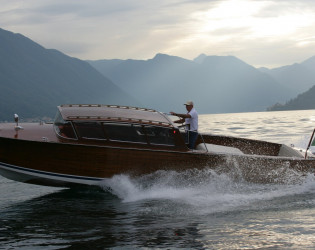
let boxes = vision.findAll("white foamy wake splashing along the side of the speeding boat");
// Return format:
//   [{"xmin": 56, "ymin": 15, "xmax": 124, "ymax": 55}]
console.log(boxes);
[{"xmin": 102, "ymin": 166, "xmax": 315, "ymax": 214}]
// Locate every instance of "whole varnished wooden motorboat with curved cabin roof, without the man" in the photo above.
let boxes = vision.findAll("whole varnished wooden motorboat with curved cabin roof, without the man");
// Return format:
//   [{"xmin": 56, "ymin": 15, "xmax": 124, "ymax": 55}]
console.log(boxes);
[{"xmin": 0, "ymin": 105, "xmax": 315, "ymax": 187}]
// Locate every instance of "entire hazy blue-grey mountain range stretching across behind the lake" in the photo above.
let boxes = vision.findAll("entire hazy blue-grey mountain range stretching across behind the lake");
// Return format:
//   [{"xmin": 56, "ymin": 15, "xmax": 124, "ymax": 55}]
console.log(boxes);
[{"xmin": 0, "ymin": 26, "xmax": 315, "ymax": 120}]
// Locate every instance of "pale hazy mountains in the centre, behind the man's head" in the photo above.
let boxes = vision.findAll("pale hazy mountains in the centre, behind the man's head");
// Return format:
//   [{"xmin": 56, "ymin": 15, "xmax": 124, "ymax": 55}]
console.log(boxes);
[{"xmin": 89, "ymin": 54, "xmax": 292, "ymax": 113}]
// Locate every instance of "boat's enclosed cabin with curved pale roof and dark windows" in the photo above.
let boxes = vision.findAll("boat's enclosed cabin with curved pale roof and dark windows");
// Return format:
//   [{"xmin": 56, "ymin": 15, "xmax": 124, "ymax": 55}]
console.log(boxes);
[{"xmin": 54, "ymin": 105, "xmax": 187, "ymax": 150}]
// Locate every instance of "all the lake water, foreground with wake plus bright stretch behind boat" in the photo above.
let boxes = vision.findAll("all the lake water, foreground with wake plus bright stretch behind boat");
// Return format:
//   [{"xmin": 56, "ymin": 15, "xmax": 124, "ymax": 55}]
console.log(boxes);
[{"xmin": 0, "ymin": 110, "xmax": 315, "ymax": 249}]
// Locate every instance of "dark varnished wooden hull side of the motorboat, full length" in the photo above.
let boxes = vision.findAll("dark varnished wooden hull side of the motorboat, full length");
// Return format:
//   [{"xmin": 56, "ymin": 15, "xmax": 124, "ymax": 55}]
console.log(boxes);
[{"xmin": 0, "ymin": 137, "xmax": 315, "ymax": 187}]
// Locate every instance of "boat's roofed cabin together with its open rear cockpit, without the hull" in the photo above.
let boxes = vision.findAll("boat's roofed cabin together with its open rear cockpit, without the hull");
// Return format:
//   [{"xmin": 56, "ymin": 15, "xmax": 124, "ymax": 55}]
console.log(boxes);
[{"xmin": 54, "ymin": 104, "xmax": 301, "ymax": 157}]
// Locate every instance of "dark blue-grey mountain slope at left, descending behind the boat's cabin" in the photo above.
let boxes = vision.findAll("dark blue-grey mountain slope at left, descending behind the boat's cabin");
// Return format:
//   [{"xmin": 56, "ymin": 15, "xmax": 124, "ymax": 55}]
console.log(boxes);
[{"xmin": 0, "ymin": 29, "xmax": 136, "ymax": 120}]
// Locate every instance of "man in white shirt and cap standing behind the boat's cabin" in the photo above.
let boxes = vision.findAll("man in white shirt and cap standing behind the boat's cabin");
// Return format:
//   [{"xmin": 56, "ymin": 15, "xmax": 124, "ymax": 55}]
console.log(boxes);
[{"xmin": 170, "ymin": 101, "xmax": 198, "ymax": 149}]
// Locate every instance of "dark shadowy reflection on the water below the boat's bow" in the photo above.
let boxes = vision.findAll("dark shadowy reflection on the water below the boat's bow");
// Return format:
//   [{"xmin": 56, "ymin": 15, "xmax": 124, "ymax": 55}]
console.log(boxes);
[{"xmin": 0, "ymin": 190, "xmax": 205, "ymax": 249}]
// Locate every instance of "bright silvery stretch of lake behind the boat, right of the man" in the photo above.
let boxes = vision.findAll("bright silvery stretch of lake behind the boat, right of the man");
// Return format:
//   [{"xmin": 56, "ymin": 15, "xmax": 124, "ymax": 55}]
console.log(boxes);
[{"xmin": 200, "ymin": 110, "xmax": 315, "ymax": 146}]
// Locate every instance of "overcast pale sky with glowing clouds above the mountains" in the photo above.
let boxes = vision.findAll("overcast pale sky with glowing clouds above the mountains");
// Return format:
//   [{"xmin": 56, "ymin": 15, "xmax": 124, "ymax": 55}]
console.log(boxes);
[{"xmin": 0, "ymin": 0, "xmax": 315, "ymax": 68}]
